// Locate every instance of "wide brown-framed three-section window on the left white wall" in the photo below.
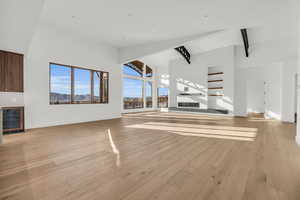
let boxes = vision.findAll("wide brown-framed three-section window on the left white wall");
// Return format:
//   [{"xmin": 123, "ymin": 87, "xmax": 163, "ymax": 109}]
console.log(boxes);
[{"xmin": 50, "ymin": 63, "xmax": 108, "ymax": 104}]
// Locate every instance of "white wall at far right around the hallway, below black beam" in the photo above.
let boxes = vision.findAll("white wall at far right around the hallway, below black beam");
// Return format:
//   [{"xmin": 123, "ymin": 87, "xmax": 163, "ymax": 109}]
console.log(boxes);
[{"xmin": 235, "ymin": 40, "xmax": 296, "ymax": 122}]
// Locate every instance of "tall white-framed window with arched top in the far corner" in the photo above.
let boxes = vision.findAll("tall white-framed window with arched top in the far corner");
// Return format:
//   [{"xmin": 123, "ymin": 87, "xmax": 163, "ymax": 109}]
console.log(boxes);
[{"xmin": 123, "ymin": 61, "xmax": 153, "ymax": 110}]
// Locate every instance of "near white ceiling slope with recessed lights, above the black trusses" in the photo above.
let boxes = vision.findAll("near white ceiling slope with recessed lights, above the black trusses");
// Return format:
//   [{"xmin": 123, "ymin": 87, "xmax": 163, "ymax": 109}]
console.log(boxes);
[{"xmin": 41, "ymin": 0, "xmax": 291, "ymax": 48}]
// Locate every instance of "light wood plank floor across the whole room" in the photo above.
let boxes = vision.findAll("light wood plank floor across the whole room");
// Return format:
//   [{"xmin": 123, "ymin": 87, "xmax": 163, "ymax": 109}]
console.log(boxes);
[{"xmin": 0, "ymin": 112, "xmax": 300, "ymax": 200}]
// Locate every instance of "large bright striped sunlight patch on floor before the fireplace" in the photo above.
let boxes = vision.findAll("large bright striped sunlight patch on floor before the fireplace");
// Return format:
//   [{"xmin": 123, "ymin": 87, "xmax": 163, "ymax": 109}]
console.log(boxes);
[{"xmin": 126, "ymin": 122, "xmax": 257, "ymax": 141}]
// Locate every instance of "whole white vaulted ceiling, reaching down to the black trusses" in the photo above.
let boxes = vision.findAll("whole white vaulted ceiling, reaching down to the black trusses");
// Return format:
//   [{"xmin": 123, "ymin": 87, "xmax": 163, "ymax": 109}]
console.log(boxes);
[{"xmin": 0, "ymin": 0, "xmax": 296, "ymax": 62}]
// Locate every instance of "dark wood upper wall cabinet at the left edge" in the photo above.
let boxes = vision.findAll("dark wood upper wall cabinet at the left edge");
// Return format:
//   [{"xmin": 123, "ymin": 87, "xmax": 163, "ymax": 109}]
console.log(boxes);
[{"xmin": 0, "ymin": 51, "xmax": 24, "ymax": 92}]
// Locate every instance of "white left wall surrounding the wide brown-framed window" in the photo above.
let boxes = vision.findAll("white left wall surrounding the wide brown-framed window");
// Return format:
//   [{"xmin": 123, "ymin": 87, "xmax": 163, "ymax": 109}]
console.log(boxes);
[{"xmin": 24, "ymin": 26, "xmax": 122, "ymax": 129}]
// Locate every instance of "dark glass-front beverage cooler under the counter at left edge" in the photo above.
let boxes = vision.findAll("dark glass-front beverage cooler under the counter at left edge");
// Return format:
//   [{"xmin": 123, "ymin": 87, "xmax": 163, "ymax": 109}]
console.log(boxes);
[{"xmin": 2, "ymin": 107, "xmax": 24, "ymax": 133}]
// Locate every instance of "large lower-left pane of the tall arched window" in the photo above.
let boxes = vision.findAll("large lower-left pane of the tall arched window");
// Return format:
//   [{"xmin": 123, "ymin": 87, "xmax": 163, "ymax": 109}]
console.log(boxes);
[{"xmin": 123, "ymin": 78, "xmax": 144, "ymax": 109}]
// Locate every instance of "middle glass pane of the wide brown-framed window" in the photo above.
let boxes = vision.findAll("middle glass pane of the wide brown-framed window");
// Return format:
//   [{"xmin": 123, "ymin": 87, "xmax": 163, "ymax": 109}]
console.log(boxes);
[{"xmin": 74, "ymin": 68, "xmax": 91, "ymax": 103}]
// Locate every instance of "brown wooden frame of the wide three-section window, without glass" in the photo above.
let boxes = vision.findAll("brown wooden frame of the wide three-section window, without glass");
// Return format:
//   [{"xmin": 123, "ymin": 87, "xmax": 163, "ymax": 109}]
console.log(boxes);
[{"xmin": 49, "ymin": 62, "xmax": 109, "ymax": 105}]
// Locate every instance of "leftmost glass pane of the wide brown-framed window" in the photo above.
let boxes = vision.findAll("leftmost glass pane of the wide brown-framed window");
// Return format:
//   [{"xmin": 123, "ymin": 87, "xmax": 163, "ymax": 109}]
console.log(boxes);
[{"xmin": 50, "ymin": 64, "xmax": 71, "ymax": 104}]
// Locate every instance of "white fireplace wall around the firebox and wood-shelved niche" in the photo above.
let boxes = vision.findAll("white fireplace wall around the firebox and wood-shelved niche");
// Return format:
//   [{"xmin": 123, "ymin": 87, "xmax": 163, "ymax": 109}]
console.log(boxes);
[{"xmin": 169, "ymin": 46, "xmax": 234, "ymax": 114}]
